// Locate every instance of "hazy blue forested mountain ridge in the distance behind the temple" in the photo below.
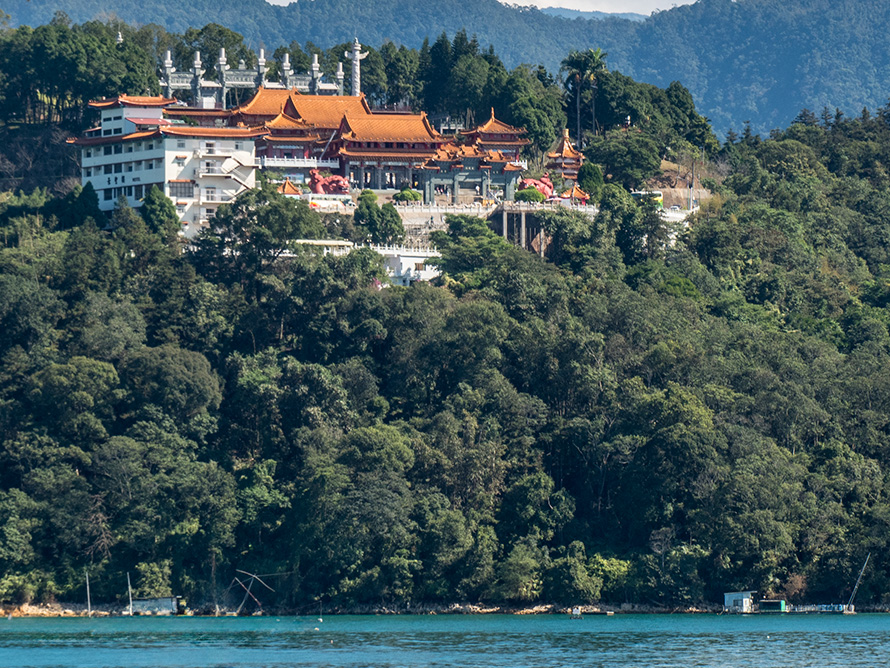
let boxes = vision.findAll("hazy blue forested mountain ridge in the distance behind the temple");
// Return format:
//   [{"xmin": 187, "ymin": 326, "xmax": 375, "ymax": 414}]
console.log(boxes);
[{"xmin": 5, "ymin": 0, "xmax": 890, "ymax": 132}]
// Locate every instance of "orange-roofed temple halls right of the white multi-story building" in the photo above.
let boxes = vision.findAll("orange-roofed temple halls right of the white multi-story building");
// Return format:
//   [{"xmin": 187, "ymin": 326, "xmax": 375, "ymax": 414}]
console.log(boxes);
[{"xmin": 164, "ymin": 87, "xmax": 529, "ymax": 204}]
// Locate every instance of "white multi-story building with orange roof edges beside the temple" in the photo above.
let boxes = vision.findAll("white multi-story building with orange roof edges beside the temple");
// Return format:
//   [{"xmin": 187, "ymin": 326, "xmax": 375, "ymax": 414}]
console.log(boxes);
[{"xmin": 73, "ymin": 95, "xmax": 268, "ymax": 237}]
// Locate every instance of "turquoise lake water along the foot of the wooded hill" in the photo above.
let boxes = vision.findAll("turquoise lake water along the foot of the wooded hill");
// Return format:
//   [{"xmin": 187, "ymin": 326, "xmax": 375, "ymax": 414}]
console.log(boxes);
[{"xmin": 0, "ymin": 614, "xmax": 890, "ymax": 668}]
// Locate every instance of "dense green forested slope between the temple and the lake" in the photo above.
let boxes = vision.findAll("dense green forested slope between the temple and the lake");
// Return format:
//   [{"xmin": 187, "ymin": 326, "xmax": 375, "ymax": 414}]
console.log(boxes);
[{"xmin": 0, "ymin": 91, "xmax": 890, "ymax": 610}]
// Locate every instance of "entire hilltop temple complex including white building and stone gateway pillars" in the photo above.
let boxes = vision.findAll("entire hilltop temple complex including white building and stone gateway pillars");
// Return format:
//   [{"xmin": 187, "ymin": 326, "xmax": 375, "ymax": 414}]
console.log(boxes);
[{"xmin": 72, "ymin": 46, "xmax": 528, "ymax": 236}]
